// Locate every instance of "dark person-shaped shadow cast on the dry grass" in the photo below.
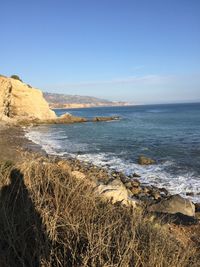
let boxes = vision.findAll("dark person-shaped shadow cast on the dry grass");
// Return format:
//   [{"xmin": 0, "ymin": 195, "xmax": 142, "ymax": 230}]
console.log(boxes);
[{"xmin": 0, "ymin": 169, "xmax": 50, "ymax": 267}]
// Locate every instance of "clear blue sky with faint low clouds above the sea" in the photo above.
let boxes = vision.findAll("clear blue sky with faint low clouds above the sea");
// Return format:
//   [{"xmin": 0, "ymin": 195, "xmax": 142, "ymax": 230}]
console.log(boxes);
[{"xmin": 0, "ymin": 0, "xmax": 200, "ymax": 103}]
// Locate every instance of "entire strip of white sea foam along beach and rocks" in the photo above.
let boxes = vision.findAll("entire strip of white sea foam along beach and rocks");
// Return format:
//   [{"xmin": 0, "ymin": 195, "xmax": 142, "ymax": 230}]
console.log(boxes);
[{"xmin": 25, "ymin": 126, "xmax": 200, "ymax": 202}]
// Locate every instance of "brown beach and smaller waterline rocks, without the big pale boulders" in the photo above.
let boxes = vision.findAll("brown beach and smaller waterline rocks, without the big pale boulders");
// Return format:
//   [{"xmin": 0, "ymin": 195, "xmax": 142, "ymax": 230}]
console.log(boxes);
[{"xmin": 0, "ymin": 124, "xmax": 199, "ymax": 208}]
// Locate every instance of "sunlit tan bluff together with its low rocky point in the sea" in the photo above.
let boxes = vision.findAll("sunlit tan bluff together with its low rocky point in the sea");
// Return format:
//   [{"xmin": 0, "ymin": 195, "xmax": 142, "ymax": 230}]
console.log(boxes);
[{"xmin": 0, "ymin": 75, "xmax": 119, "ymax": 125}]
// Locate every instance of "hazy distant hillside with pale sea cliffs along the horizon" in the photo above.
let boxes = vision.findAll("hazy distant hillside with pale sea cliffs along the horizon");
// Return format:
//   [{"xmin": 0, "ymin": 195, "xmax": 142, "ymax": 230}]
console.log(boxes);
[{"xmin": 44, "ymin": 93, "xmax": 128, "ymax": 108}]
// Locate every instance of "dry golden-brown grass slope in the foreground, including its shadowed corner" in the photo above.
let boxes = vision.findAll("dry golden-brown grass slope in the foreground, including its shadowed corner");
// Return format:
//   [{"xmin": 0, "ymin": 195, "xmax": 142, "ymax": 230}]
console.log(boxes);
[{"xmin": 0, "ymin": 158, "xmax": 199, "ymax": 267}]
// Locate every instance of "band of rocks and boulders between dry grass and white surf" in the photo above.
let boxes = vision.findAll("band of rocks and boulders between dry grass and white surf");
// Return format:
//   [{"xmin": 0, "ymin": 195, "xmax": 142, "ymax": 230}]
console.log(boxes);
[{"xmin": 57, "ymin": 158, "xmax": 200, "ymax": 224}]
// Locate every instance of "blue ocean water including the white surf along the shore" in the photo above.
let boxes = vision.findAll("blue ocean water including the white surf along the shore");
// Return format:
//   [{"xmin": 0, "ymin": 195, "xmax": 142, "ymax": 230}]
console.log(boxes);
[{"xmin": 26, "ymin": 103, "xmax": 200, "ymax": 202}]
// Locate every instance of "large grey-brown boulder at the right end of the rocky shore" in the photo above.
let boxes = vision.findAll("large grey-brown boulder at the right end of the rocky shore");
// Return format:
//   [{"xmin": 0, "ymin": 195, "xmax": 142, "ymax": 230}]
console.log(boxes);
[{"xmin": 148, "ymin": 195, "xmax": 195, "ymax": 217}]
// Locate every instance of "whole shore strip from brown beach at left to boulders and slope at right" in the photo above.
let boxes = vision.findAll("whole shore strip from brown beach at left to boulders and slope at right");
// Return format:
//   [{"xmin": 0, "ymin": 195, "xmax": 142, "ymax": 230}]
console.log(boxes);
[{"xmin": 0, "ymin": 124, "xmax": 200, "ymax": 256}]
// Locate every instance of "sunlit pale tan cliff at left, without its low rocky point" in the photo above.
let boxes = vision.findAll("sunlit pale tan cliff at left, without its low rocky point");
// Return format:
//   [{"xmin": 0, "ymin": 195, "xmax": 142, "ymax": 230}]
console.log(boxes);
[{"xmin": 0, "ymin": 77, "xmax": 56, "ymax": 120}]
